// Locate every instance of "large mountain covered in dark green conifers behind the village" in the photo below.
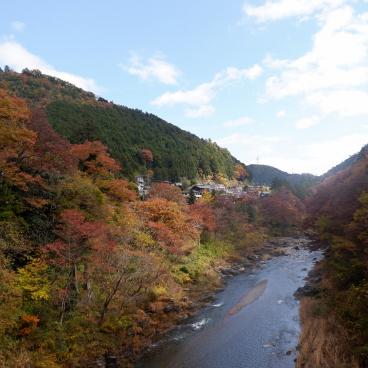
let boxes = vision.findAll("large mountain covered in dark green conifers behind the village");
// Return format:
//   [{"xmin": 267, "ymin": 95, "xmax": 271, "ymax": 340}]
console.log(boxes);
[{"xmin": 0, "ymin": 69, "xmax": 240, "ymax": 180}]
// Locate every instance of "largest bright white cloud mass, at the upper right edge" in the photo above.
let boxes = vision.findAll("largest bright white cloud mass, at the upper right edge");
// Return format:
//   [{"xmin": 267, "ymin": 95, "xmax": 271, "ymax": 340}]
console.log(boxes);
[{"xmin": 264, "ymin": 6, "xmax": 368, "ymax": 116}]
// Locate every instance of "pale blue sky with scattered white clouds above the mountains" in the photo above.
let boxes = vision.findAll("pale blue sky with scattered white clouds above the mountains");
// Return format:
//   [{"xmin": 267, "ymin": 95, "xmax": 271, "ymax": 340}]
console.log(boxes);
[{"xmin": 0, "ymin": 0, "xmax": 368, "ymax": 175}]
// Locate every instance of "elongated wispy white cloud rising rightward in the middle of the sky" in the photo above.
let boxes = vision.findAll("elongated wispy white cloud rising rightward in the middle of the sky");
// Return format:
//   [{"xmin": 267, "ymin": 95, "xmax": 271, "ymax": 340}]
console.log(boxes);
[{"xmin": 151, "ymin": 65, "xmax": 263, "ymax": 117}]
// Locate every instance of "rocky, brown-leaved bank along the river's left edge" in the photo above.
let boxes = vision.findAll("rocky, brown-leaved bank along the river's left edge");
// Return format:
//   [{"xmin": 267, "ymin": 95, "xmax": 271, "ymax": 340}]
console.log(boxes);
[{"xmin": 113, "ymin": 235, "xmax": 311, "ymax": 367}]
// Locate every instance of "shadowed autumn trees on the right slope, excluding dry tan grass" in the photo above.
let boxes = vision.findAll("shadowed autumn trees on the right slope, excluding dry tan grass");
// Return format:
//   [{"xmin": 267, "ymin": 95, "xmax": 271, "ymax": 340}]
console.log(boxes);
[{"xmin": 307, "ymin": 148, "xmax": 368, "ymax": 367}]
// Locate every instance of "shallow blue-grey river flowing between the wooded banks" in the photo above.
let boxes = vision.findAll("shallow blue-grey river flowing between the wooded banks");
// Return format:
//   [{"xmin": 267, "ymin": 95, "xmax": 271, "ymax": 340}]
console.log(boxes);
[{"xmin": 136, "ymin": 239, "xmax": 322, "ymax": 368}]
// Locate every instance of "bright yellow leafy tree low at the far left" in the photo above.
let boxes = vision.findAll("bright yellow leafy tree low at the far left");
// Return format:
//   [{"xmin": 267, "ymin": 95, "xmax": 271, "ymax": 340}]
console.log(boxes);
[{"xmin": 18, "ymin": 259, "xmax": 50, "ymax": 301}]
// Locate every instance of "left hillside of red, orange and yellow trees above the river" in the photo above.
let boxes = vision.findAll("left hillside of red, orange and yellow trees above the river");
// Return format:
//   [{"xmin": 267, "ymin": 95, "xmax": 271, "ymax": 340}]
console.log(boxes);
[{"xmin": 0, "ymin": 89, "xmax": 304, "ymax": 368}]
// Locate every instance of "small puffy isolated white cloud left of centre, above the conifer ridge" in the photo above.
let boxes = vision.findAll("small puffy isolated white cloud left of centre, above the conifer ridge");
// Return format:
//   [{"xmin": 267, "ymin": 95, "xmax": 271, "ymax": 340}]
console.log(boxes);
[{"xmin": 120, "ymin": 53, "xmax": 181, "ymax": 84}]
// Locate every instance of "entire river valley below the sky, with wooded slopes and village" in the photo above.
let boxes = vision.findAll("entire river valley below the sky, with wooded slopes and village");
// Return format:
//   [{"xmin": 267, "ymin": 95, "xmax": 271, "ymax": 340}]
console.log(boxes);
[{"xmin": 0, "ymin": 68, "xmax": 368, "ymax": 368}]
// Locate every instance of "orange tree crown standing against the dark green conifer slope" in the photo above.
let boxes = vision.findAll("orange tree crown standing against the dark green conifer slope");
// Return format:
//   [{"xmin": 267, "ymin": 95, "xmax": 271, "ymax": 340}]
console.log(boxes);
[{"xmin": 71, "ymin": 141, "xmax": 121, "ymax": 177}]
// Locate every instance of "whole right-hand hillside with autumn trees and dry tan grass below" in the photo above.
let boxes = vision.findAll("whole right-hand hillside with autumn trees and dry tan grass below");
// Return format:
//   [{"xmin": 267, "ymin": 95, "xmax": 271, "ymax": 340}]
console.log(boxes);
[{"xmin": 298, "ymin": 148, "xmax": 368, "ymax": 368}]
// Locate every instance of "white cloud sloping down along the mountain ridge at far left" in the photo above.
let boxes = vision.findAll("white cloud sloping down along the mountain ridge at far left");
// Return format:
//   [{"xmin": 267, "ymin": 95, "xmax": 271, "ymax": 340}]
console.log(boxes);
[{"xmin": 0, "ymin": 40, "xmax": 100, "ymax": 92}]
